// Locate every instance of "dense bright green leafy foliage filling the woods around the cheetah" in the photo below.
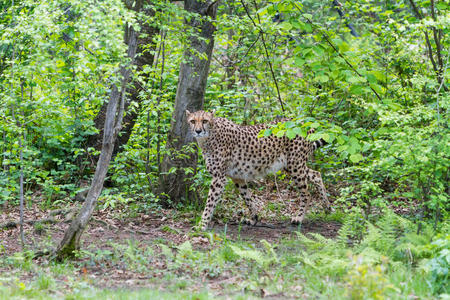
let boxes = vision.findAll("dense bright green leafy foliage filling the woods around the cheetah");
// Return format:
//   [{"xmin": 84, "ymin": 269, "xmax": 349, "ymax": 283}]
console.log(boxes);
[{"xmin": 0, "ymin": 0, "xmax": 450, "ymax": 299}]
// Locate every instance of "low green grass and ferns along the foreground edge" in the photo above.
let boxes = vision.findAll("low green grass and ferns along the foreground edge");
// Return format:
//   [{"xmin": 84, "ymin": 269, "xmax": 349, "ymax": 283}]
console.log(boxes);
[{"xmin": 0, "ymin": 210, "xmax": 450, "ymax": 299}]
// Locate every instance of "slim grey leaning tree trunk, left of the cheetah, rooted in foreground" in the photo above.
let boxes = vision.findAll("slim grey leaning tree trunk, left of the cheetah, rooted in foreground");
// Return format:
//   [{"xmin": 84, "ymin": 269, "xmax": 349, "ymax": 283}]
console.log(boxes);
[{"xmin": 55, "ymin": 27, "xmax": 137, "ymax": 260}]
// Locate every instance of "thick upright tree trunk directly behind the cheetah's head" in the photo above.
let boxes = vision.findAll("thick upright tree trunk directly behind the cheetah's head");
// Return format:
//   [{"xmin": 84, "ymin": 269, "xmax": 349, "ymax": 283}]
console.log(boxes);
[{"xmin": 160, "ymin": 0, "xmax": 217, "ymax": 203}]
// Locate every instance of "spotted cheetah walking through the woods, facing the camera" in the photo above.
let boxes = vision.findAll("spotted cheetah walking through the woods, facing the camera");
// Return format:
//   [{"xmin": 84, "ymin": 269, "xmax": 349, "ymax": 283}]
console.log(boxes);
[{"xmin": 186, "ymin": 110, "xmax": 330, "ymax": 230}]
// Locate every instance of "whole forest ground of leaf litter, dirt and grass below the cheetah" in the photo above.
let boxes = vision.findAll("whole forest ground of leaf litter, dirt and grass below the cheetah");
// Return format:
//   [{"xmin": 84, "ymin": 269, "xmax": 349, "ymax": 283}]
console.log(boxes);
[{"xmin": 0, "ymin": 192, "xmax": 442, "ymax": 299}]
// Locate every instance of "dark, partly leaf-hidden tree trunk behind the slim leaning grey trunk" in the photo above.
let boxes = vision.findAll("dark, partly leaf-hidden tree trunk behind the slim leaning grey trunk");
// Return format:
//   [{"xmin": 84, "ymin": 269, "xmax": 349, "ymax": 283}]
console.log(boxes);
[{"xmin": 81, "ymin": 0, "xmax": 159, "ymax": 171}]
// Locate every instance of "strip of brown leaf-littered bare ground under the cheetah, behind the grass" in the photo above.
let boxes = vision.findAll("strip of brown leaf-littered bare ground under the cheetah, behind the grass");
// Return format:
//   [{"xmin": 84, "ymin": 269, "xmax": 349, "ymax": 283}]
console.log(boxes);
[{"xmin": 0, "ymin": 184, "xmax": 342, "ymax": 255}]
